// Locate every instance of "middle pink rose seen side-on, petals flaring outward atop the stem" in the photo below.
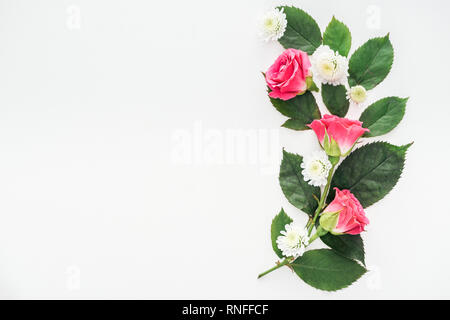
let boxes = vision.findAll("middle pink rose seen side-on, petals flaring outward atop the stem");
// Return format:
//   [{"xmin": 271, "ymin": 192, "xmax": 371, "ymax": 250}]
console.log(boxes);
[{"xmin": 308, "ymin": 114, "xmax": 370, "ymax": 156}]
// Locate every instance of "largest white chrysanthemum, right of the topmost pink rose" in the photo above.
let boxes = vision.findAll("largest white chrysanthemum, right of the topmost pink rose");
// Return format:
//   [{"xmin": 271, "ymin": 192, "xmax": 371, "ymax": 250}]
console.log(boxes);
[{"xmin": 311, "ymin": 46, "xmax": 348, "ymax": 86}]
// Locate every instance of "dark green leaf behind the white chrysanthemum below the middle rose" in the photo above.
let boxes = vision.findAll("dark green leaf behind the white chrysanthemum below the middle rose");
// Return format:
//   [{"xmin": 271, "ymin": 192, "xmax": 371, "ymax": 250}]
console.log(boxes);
[{"xmin": 279, "ymin": 150, "xmax": 320, "ymax": 216}]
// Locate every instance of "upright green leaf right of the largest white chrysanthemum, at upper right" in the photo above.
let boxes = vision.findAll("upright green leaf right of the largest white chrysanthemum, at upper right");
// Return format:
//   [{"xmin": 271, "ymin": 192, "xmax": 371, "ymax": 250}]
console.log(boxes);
[{"xmin": 348, "ymin": 34, "xmax": 394, "ymax": 90}]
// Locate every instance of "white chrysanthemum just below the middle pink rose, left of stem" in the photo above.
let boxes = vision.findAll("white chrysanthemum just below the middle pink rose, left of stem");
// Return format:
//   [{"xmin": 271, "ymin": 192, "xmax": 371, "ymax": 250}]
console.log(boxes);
[{"xmin": 301, "ymin": 151, "xmax": 331, "ymax": 187}]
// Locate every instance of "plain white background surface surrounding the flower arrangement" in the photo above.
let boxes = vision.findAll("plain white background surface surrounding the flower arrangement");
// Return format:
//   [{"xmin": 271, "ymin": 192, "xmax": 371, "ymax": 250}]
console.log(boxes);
[{"xmin": 0, "ymin": 0, "xmax": 450, "ymax": 299}]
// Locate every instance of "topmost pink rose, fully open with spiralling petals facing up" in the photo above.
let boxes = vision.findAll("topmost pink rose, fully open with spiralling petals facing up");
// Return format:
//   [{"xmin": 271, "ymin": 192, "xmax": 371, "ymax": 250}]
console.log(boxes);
[{"xmin": 266, "ymin": 49, "xmax": 311, "ymax": 100}]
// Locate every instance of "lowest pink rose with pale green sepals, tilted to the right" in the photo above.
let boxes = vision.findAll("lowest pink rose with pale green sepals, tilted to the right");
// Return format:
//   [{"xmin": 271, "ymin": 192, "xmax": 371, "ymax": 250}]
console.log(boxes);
[{"xmin": 320, "ymin": 188, "xmax": 369, "ymax": 235}]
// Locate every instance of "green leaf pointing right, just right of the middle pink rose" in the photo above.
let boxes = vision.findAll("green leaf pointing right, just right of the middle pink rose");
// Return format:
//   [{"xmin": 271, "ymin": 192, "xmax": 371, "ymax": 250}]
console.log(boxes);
[{"xmin": 359, "ymin": 97, "xmax": 408, "ymax": 137}]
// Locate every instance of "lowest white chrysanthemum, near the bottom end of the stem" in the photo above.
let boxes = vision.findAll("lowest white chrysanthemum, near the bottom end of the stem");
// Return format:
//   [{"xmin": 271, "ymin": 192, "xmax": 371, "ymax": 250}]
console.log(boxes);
[{"xmin": 277, "ymin": 222, "xmax": 309, "ymax": 258}]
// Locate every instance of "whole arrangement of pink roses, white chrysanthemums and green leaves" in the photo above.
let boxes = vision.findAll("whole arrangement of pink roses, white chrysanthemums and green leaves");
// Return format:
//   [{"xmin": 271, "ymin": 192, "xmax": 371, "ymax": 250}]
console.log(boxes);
[{"xmin": 258, "ymin": 6, "xmax": 411, "ymax": 291}]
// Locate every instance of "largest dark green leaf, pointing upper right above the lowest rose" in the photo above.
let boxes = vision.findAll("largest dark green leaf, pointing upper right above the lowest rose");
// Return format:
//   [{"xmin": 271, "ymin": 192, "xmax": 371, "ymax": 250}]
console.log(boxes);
[{"xmin": 328, "ymin": 142, "xmax": 411, "ymax": 208}]
